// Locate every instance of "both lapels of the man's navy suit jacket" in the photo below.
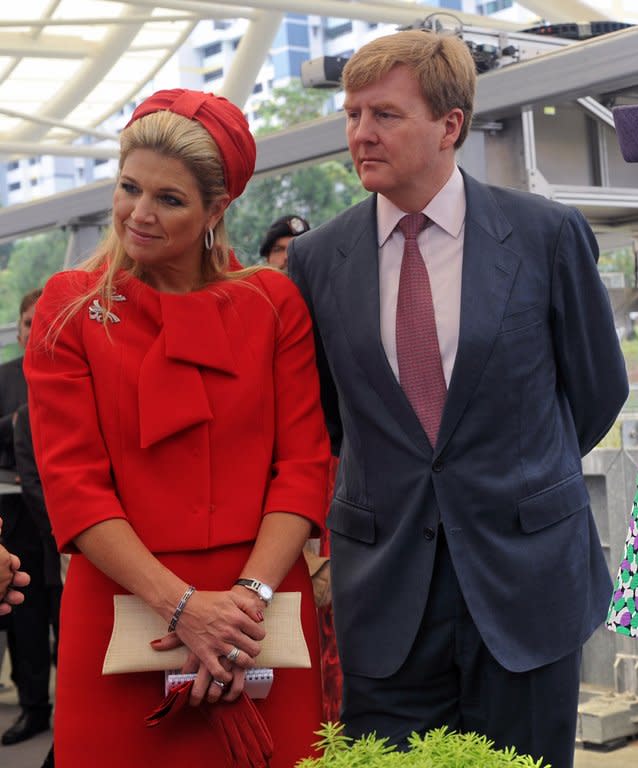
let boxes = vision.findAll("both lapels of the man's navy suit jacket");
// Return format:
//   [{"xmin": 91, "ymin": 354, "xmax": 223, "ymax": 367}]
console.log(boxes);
[{"xmin": 330, "ymin": 178, "xmax": 520, "ymax": 454}]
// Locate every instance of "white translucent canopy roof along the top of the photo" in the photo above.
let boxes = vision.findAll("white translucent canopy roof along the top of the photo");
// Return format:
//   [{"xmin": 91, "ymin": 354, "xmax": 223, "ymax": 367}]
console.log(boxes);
[{"xmin": 0, "ymin": 0, "xmax": 638, "ymax": 157}]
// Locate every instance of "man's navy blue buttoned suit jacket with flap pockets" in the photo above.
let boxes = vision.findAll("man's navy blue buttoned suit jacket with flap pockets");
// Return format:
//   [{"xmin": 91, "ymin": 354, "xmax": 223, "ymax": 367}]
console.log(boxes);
[{"xmin": 289, "ymin": 174, "xmax": 628, "ymax": 677}]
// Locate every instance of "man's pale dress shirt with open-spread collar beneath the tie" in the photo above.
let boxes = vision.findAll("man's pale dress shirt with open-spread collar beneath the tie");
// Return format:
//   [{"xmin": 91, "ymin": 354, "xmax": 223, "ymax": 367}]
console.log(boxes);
[{"xmin": 377, "ymin": 167, "xmax": 465, "ymax": 386}]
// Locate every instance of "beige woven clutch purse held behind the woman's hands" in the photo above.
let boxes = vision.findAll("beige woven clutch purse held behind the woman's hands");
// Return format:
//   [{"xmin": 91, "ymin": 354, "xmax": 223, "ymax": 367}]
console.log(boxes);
[{"xmin": 102, "ymin": 592, "xmax": 310, "ymax": 675}]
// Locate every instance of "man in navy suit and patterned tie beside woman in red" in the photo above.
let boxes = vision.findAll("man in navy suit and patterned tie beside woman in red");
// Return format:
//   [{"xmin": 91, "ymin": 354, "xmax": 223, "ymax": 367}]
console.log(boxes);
[{"xmin": 289, "ymin": 30, "xmax": 628, "ymax": 768}]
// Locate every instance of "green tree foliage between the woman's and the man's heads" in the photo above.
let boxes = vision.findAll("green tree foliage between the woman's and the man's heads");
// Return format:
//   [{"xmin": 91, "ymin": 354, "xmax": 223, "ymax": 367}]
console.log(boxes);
[{"xmin": 226, "ymin": 80, "xmax": 368, "ymax": 265}]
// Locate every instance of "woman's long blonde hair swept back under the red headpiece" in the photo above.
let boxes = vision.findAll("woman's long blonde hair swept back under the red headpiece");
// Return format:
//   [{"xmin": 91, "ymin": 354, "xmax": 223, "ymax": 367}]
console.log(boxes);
[{"xmin": 50, "ymin": 110, "xmax": 268, "ymax": 341}]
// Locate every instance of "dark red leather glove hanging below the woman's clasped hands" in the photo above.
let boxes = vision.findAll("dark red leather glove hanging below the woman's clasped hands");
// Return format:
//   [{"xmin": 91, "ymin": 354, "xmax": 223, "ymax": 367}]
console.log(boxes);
[{"xmin": 199, "ymin": 693, "xmax": 273, "ymax": 768}]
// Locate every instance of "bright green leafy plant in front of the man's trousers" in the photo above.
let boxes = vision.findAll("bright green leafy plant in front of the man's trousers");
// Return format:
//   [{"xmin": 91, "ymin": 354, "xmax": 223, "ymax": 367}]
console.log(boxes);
[{"xmin": 296, "ymin": 723, "xmax": 551, "ymax": 768}]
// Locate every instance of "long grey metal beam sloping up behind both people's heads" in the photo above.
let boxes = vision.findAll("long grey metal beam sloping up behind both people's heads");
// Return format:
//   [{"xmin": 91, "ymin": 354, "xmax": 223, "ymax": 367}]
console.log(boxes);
[{"xmin": 0, "ymin": 22, "xmax": 638, "ymax": 251}]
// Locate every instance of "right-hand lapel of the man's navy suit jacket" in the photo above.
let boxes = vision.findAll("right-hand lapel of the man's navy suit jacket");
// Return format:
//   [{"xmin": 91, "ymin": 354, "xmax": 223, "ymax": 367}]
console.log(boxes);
[{"xmin": 437, "ymin": 174, "xmax": 520, "ymax": 453}]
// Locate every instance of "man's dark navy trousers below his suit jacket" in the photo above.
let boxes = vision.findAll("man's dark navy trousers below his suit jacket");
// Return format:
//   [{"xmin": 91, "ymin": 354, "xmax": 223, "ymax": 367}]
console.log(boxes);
[{"xmin": 342, "ymin": 527, "xmax": 581, "ymax": 768}]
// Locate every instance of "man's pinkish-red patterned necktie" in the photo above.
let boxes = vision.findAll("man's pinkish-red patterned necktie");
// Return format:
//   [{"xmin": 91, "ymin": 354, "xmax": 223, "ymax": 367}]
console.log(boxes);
[{"xmin": 396, "ymin": 213, "xmax": 447, "ymax": 447}]
